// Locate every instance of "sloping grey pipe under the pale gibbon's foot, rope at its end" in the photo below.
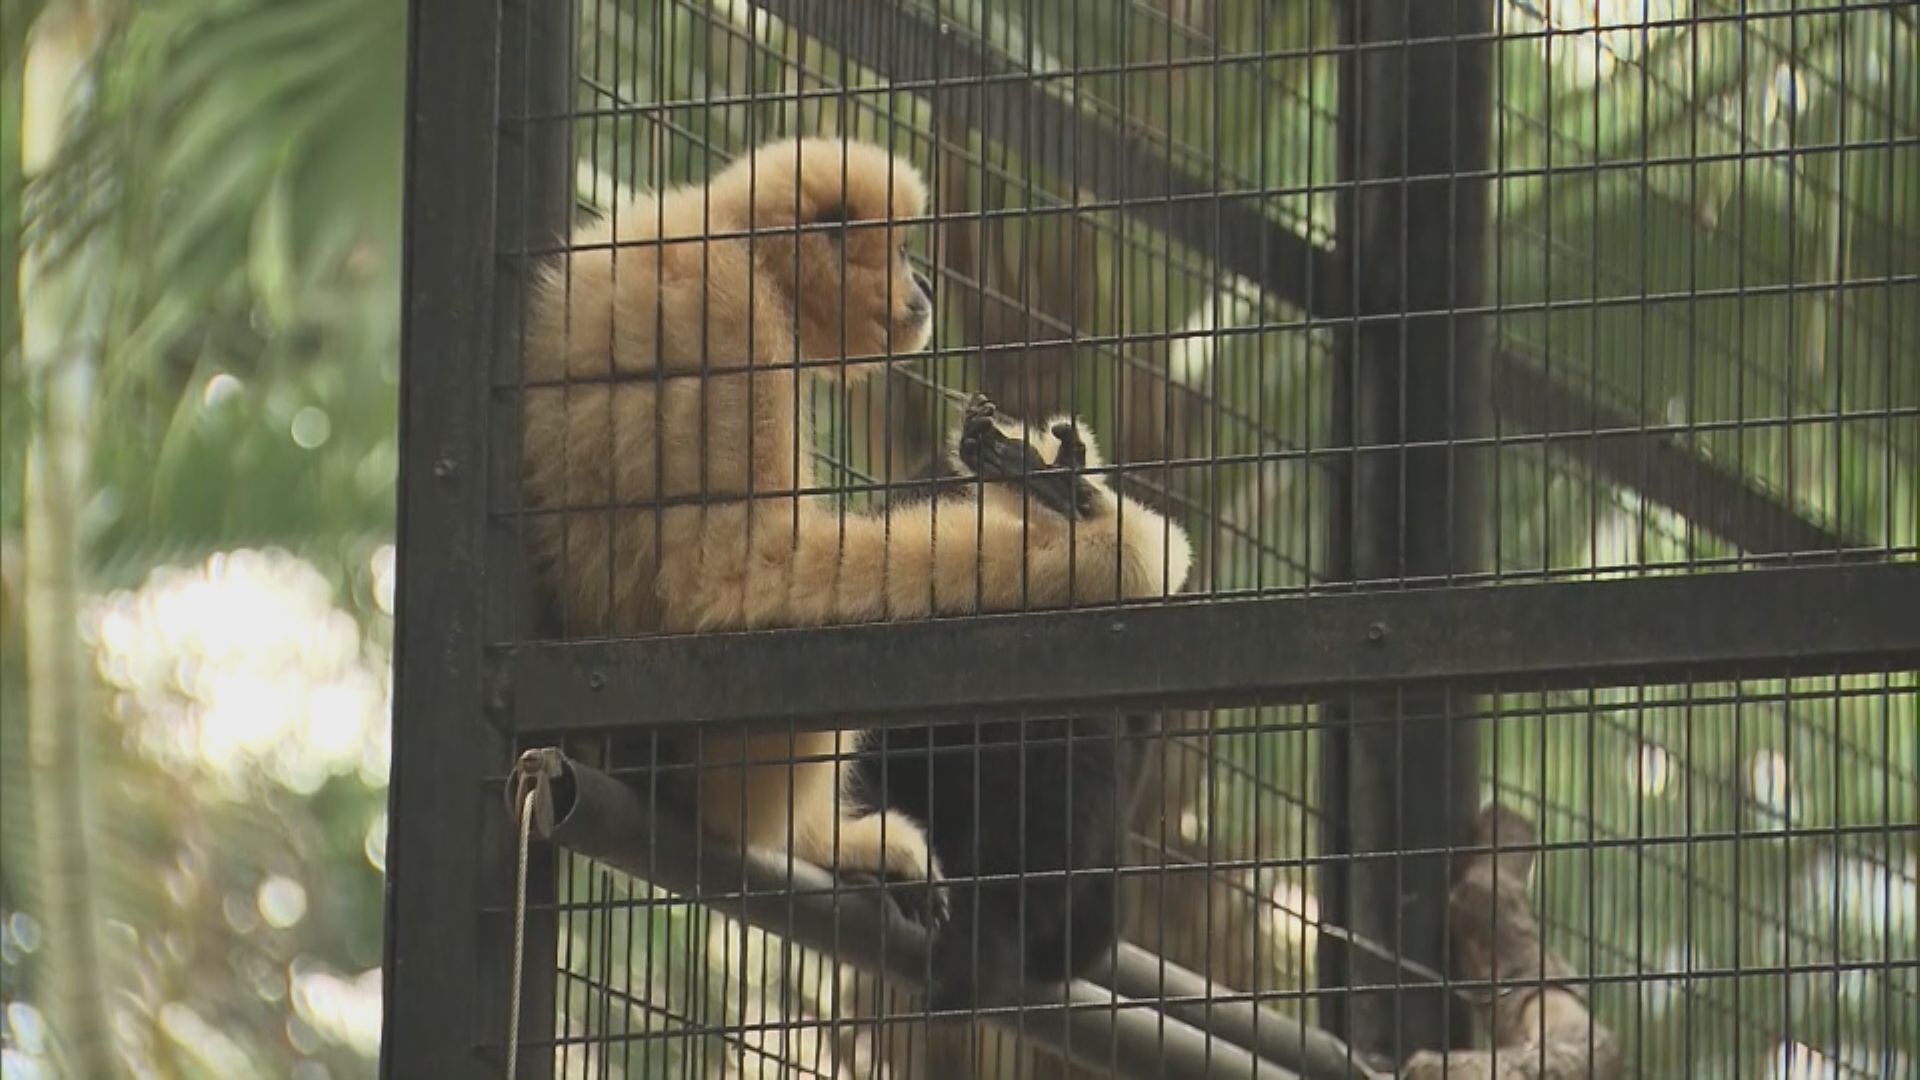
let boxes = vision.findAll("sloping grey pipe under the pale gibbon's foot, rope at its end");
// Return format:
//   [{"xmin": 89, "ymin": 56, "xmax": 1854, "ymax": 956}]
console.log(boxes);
[{"xmin": 509, "ymin": 749, "xmax": 1297, "ymax": 1080}]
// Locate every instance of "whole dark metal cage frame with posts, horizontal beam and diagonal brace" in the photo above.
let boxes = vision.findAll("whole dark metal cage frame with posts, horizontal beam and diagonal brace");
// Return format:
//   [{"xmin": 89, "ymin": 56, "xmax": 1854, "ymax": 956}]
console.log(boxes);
[{"xmin": 380, "ymin": 0, "xmax": 1920, "ymax": 1078}]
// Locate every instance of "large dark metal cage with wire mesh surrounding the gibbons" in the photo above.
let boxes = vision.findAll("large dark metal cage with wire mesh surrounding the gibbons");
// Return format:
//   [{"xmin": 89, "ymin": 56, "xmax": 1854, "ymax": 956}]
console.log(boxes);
[{"xmin": 382, "ymin": 0, "xmax": 1920, "ymax": 1080}]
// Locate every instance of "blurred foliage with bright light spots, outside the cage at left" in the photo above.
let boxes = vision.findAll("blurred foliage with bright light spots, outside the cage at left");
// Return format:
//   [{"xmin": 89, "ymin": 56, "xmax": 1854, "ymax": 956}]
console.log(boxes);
[{"xmin": 0, "ymin": 0, "xmax": 407, "ymax": 1076}]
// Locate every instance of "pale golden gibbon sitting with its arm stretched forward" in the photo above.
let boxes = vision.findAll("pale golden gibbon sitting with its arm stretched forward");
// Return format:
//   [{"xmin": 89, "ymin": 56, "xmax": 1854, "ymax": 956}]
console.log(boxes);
[{"xmin": 522, "ymin": 138, "xmax": 1190, "ymax": 941}]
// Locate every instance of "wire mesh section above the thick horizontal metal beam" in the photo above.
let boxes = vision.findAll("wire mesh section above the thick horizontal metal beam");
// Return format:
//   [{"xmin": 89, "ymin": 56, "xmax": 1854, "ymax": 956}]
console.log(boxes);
[{"xmin": 506, "ymin": 0, "xmax": 1920, "ymax": 630}]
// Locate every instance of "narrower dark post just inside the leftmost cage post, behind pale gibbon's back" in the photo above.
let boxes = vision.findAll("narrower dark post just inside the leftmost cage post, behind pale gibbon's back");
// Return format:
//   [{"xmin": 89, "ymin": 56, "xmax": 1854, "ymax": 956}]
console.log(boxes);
[{"xmin": 482, "ymin": 0, "xmax": 578, "ymax": 1080}]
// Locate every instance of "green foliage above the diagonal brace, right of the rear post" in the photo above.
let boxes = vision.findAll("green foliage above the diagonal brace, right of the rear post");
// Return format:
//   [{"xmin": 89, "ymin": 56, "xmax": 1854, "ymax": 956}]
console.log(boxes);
[{"xmin": 1494, "ymin": 4, "xmax": 1920, "ymax": 546}]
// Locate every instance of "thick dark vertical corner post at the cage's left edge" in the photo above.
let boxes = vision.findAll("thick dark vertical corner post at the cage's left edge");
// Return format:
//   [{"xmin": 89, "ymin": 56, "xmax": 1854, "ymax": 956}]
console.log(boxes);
[{"xmin": 380, "ymin": 0, "xmax": 572, "ymax": 1078}]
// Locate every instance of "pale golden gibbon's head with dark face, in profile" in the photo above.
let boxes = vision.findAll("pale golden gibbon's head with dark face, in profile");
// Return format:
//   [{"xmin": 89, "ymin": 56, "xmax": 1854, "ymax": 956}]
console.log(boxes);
[{"xmin": 710, "ymin": 138, "xmax": 933, "ymax": 371}]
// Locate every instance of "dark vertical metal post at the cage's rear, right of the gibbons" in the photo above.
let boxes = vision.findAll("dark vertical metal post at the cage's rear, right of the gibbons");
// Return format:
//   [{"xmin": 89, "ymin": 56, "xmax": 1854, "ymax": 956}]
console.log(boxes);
[{"xmin": 1319, "ymin": 0, "xmax": 1492, "ymax": 1063}]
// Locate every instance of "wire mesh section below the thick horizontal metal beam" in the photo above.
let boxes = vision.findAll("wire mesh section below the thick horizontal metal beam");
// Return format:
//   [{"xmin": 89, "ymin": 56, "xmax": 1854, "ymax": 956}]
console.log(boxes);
[{"xmin": 522, "ymin": 673, "xmax": 1920, "ymax": 1078}]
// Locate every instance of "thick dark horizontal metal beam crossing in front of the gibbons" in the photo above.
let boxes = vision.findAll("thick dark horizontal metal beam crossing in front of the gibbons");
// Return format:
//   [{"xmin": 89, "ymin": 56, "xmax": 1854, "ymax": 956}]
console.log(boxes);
[{"xmin": 493, "ymin": 563, "xmax": 1920, "ymax": 732}]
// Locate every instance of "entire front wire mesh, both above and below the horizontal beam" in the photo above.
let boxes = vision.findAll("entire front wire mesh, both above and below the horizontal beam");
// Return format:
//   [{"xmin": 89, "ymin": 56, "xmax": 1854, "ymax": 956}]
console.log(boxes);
[{"xmin": 393, "ymin": 0, "xmax": 1920, "ymax": 1080}]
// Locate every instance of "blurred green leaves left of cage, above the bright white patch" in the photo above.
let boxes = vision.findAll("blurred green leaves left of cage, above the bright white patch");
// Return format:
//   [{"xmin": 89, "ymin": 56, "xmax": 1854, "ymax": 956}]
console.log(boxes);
[{"xmin": 25, "ymin": 0, "xmax": 405, "ymax": 582}]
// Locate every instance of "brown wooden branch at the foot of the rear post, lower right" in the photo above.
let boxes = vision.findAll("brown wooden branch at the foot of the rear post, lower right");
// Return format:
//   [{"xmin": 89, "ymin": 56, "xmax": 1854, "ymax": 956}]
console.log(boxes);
[{"xmin": 1400, "ymin": 803, "xmax": 1620, "ymax": 1080}]
